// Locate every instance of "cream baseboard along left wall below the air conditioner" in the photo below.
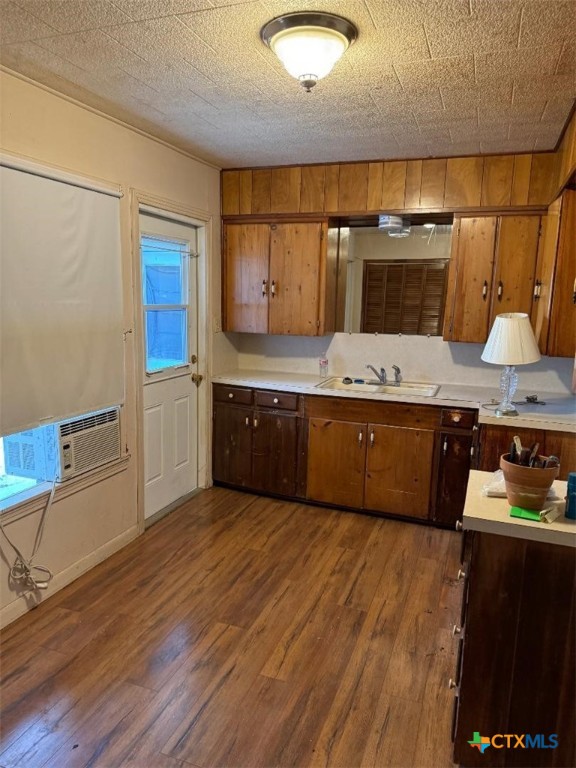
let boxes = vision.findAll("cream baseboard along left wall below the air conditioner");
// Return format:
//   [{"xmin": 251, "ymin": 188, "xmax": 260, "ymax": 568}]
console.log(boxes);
[{"xmin": 0, "ymin": 525, "xmax": 138, "ymax": 628}]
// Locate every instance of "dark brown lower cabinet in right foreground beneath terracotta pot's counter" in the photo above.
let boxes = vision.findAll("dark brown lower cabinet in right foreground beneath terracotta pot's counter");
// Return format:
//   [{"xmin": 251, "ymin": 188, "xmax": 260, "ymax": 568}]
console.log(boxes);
[{"xmin": 454, "ymin": 532, "xmax": 576, "ymax": 768}]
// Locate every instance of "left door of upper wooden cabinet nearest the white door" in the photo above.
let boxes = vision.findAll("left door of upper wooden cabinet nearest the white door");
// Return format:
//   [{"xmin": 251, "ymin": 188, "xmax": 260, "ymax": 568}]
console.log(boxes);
[{"xmin": 222, "ymin": 224, "xmax": 270, "ymax": 333}]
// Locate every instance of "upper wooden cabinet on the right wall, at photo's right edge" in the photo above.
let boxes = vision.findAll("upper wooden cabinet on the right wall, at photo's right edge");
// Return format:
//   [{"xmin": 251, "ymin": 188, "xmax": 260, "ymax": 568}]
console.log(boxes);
[{"xmin": 531, "ymin": 189, "xmax": 576, "ymax": 357}]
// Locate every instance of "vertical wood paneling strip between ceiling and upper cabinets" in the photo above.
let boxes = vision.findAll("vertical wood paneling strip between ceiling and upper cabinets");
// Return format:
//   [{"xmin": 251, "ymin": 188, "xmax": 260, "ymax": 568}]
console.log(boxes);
[{"xmin": 222, "ymin": 153, "xmax": 560, "ymax": 216}]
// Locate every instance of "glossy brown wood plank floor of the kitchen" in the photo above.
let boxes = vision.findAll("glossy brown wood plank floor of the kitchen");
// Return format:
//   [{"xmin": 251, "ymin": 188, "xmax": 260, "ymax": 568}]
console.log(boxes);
[{"xmin": 0, "ymin": 488, "xmax": 461, "ymax": 768}]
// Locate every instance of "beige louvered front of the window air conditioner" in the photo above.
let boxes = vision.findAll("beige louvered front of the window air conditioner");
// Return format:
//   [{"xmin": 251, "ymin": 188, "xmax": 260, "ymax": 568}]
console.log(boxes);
[{"xmin": 58, "ymin": 408, "xmax": 120, "ymax": 480}]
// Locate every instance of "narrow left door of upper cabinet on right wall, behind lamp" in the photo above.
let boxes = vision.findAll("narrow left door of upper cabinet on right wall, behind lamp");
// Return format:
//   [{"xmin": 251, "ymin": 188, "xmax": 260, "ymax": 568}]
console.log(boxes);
[{"xmin": 530, "ymin": 198, "xmax": 562, "ymax": 355}]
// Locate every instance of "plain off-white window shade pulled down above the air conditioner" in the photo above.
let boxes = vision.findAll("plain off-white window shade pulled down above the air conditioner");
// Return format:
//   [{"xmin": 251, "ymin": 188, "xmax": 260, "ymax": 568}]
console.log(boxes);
[{"xmin": 0, "ymin": 167, "xmax": 124, "ymax": 435}]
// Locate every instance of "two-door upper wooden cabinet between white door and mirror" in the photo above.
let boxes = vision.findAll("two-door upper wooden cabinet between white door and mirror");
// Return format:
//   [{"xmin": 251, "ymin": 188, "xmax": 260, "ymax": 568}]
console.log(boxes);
[{"xmin": 223, "ymin": 222, "xmax": 329, "ymax": 336}]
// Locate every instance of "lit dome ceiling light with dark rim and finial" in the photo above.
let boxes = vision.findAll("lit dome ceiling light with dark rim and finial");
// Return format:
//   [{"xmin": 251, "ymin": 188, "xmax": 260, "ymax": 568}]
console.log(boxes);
[{"xmin": 260, "ymin": 12, "xmax": 358, "ymax": 92}]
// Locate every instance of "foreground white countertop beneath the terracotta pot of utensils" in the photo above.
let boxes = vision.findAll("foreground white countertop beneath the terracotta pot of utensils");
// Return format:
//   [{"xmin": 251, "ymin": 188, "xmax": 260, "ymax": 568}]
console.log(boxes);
[{"xmin": 462, "ymin": 469, "xmax": 576, "ymax": 547}]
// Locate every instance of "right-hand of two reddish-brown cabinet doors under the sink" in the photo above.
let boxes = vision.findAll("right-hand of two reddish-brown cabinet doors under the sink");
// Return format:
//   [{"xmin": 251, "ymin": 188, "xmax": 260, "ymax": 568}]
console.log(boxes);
[{"xmin": 364, "ymin": 424, "xmax": 434, "ymax": 519}]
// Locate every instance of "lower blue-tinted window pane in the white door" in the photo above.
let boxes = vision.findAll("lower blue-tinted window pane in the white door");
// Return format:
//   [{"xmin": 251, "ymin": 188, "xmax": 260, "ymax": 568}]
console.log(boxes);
[{"xmin": 144, "ymin": 309, "xmax": 188, "ymax": 372}]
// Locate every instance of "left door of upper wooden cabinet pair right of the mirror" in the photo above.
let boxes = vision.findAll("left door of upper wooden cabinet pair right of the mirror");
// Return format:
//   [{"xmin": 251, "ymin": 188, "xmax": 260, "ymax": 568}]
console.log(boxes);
[{"xmin": 444, "ymin": 216, "xmax": 497, "ymax": 342}]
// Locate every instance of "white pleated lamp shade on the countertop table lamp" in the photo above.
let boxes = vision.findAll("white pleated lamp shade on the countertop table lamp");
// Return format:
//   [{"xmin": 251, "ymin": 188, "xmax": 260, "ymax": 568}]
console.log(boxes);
[{"xmin": 481, "ymin": 312, "xmax": 540, "ymax": 365}]
